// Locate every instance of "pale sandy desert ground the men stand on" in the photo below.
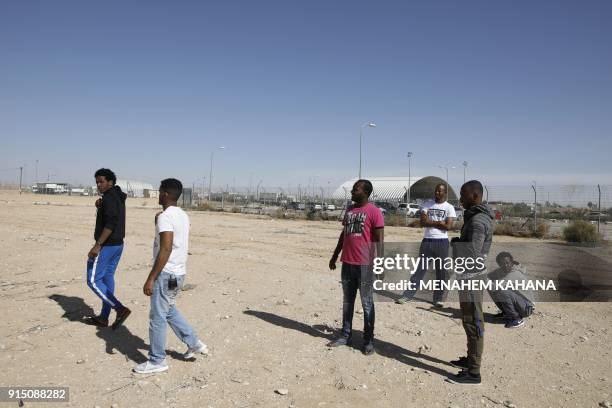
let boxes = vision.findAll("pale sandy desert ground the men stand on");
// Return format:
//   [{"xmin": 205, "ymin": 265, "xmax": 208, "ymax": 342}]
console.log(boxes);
[{"xmin": 0, "ymin": 192, "xmax": 612, "ymax": 408}]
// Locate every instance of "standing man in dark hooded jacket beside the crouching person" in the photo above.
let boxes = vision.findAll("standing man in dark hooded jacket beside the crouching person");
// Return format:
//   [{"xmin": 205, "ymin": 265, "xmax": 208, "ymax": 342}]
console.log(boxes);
[{"xmin": 449, "ymin": 180, "xmax": 495, "ymax": 384}]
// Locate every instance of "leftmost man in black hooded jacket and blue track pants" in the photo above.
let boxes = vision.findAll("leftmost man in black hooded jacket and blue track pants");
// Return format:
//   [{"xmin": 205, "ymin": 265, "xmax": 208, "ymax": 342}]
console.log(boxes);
[{"xmin": 87, "ymin": 169, "xmax": 131, "ymax": 330}]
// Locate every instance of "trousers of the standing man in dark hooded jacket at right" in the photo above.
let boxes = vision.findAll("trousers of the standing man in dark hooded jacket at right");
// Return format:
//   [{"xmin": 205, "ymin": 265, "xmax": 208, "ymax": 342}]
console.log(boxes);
[{"xmin": 459, "ymin": 290, "xmax": 484, "ymax": 374}]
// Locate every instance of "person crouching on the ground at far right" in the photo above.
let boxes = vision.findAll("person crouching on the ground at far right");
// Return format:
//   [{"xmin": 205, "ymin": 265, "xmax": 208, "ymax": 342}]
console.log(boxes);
[{"xmin": 488, "ymin": 252, "xmax": 535, "ymax": 329}]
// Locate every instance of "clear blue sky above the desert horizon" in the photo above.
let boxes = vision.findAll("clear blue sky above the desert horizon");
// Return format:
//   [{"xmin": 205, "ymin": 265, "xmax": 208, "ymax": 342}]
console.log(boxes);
[{"xmin": 0, "ymin": 1, "xmax": 612, "ymax": 187}]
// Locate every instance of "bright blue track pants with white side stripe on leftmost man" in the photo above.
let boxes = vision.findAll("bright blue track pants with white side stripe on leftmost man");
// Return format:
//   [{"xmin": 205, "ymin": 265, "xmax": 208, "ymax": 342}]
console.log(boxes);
[{"xmin": 87, "ymin": 245, "xmax": 123, "ymax": 319}]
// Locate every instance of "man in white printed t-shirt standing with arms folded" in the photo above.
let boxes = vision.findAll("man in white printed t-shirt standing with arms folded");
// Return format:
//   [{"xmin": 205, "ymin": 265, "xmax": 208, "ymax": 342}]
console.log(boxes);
[{"xmin": 395, "ymin": 183, "xmax": 457, "ymax": 307}]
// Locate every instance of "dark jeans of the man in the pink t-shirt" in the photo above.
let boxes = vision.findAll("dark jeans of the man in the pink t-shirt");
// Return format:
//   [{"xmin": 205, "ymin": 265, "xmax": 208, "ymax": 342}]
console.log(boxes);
[{"xmin": 342, "ymin": 263, "xmax": 374, "ymax": 344}]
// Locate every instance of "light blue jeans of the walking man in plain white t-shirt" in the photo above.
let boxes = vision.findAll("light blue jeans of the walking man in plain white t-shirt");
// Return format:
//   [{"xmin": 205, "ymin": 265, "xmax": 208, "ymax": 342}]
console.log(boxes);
[{"xmin": 149, "ymin": 272, "xmax": 199, "ymax": 364}]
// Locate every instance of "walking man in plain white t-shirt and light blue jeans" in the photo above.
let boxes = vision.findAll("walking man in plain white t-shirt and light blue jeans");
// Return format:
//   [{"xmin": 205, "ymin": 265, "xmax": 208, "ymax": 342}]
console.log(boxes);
[{"xmin": 134, "ymin": 179, "xmax": 208, "ymax": 374}]
